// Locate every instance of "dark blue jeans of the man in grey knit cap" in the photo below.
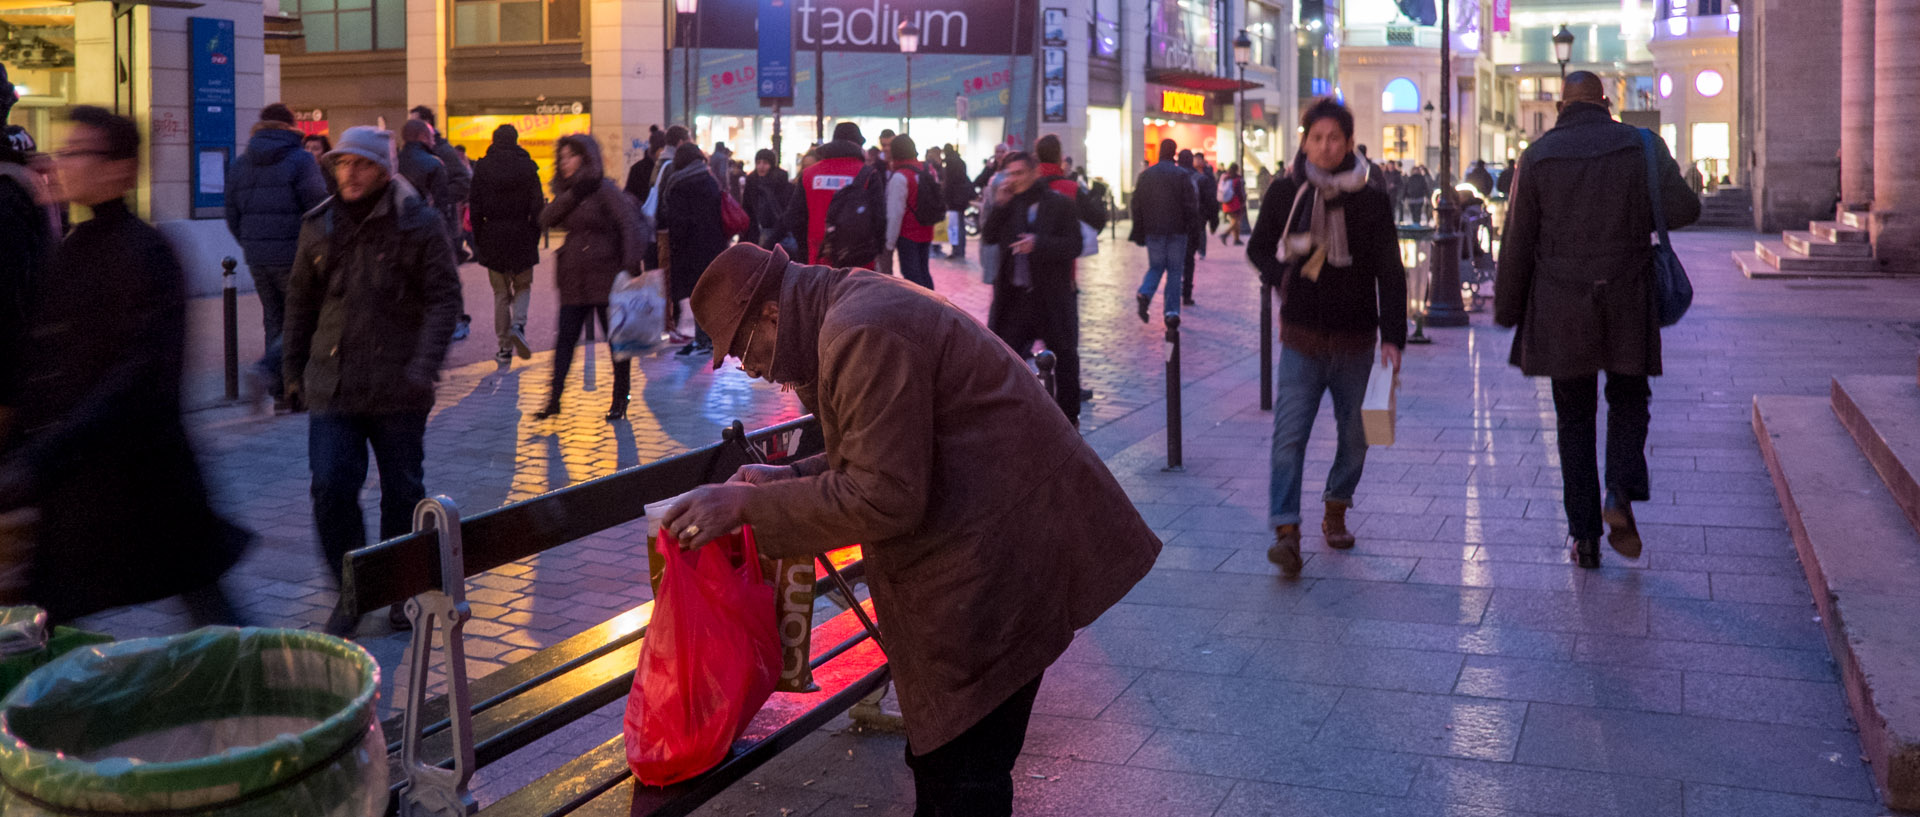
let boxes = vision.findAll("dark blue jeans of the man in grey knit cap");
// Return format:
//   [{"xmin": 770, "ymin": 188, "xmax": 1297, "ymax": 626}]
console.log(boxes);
[{"xmin": 307, "ymin": 412, "xmax": 426, "ymax": 581}]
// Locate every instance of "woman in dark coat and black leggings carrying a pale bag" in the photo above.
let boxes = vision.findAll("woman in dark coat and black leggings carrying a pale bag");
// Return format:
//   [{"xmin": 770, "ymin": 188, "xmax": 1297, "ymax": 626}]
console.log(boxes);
[{"xmin": 534, "ymin": 134, "xmax": 645, "ymax": 422}]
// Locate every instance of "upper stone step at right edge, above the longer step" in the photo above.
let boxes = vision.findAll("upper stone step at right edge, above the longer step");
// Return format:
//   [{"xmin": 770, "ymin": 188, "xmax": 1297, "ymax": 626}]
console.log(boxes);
[{"xmin": 1832, "ymin": 374, "xmax": 1920, "ymax": 531}]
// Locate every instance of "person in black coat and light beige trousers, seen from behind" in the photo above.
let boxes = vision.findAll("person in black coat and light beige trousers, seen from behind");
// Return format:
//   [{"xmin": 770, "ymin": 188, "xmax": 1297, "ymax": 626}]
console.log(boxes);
[{"xmin": 468, "ymin": 125, "xmax": 547, "ymax": 364}]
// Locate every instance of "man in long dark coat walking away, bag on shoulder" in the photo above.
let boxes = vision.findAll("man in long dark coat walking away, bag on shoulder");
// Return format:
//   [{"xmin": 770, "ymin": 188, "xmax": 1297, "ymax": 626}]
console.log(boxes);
[{"xmin": 1494, "ymin": 71, "xmax": 1699, "ymax": 568}]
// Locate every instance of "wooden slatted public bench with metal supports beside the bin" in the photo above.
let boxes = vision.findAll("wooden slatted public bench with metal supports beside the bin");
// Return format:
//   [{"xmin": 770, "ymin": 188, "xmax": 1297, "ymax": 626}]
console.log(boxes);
[{"xmin": 340, "ymin": 418, "xmax": 887, "ymax": 817}]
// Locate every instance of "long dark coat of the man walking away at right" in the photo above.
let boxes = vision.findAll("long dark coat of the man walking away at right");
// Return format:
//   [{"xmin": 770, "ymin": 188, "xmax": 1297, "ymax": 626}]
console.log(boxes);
[{"xmin": 1494, "ymin": 104, "xmax": 1699, "ymax": 378}]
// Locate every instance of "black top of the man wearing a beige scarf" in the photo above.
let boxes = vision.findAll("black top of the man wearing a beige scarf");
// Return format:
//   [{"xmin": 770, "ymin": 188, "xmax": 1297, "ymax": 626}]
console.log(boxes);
[{"xmin": 1246, "ymin": 157, "xmax": 1407, "ymax": 347}]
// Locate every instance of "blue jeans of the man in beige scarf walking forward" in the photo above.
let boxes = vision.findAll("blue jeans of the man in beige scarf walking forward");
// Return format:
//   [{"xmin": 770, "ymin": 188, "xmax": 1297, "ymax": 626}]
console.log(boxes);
[{"xmin": 1267, "ymin": 345, "xmax": 1375, "ymax": 525}]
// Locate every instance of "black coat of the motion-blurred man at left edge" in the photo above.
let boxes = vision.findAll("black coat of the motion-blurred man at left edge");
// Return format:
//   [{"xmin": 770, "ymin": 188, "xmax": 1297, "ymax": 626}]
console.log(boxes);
[{"xmin": 0, "ymin": 201, "xmax": 250, "ymax": 619}]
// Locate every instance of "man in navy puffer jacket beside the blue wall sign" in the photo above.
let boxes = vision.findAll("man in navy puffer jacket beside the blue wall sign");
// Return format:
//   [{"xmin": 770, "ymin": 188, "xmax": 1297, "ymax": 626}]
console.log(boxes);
[{"xmin": 227, "ymin": 102, "xmax": 326, "ymax": 412}]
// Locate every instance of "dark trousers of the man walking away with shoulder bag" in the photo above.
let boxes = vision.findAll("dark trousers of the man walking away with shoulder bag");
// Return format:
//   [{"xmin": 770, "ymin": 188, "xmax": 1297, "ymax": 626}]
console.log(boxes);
[{"xmin": 1553, "ymin": 372, "xmax": 1651, "ymax": 539}]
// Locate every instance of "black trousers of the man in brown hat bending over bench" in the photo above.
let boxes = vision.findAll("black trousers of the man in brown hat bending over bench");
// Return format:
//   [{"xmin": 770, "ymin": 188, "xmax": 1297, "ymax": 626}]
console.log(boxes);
[{"xmin": 906, "ymin": 675, "xmax": 1044, "ymax": 817}]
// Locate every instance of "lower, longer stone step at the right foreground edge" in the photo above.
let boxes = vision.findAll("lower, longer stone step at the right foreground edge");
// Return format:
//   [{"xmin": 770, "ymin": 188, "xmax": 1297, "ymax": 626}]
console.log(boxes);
[{"xmin": 1753, "ymin": 395, "xmax": 1920, "ymax": 809}]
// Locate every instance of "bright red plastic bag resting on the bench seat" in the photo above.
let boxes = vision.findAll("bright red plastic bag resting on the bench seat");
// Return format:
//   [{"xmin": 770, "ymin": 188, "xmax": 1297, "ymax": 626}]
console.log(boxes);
[{"xmin": 626, "ymin": 529, "xmax": 780, "ymax": 786}]
